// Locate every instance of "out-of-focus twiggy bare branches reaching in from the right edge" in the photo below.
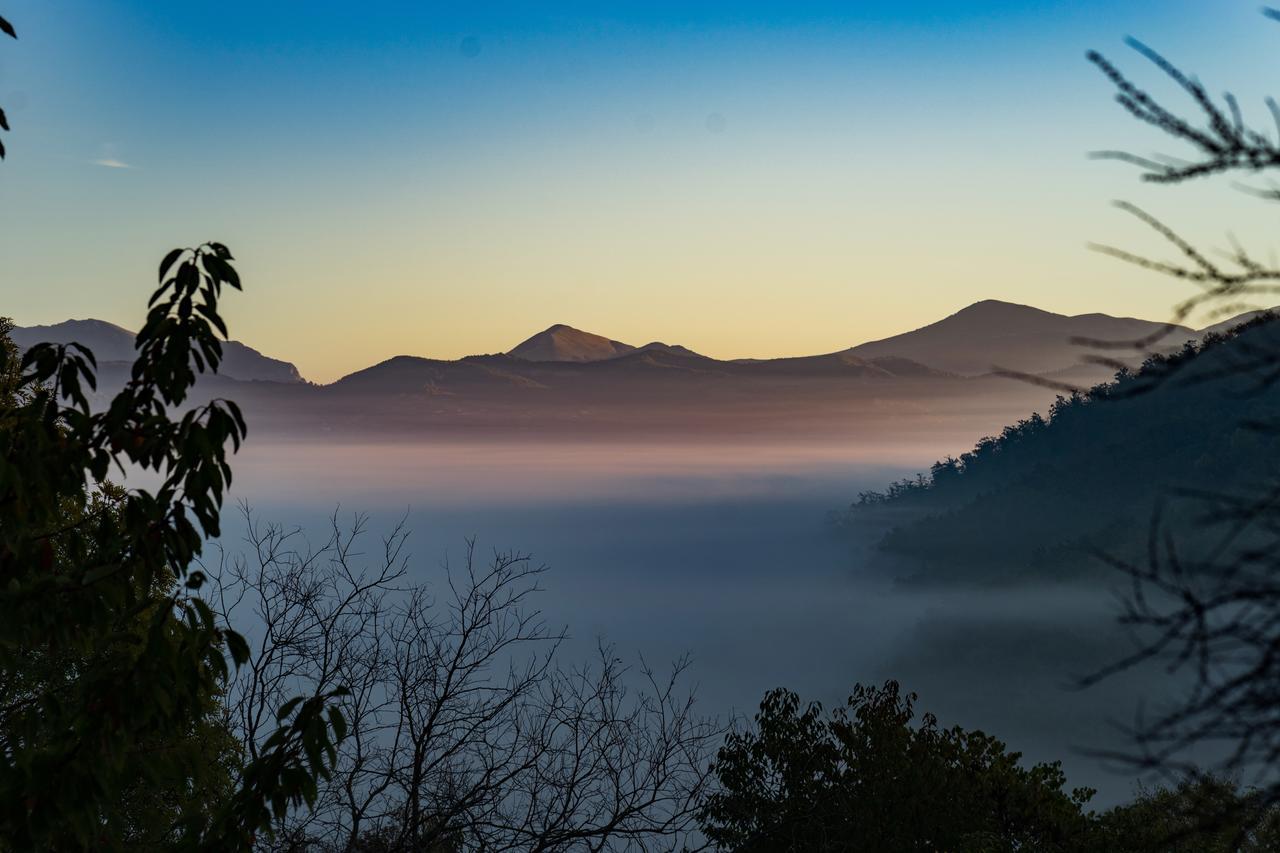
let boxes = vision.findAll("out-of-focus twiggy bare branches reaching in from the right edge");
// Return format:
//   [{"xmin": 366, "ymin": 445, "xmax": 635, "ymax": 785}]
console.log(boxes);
[{"xmin": 1085, "ymin": 9, "xmax": 1280, "ymax": 813}]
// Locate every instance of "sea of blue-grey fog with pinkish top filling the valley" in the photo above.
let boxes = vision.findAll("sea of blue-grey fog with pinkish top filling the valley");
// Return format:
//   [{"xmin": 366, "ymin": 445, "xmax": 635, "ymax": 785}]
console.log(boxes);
[{"xmin": 209, "ymin": 441, "xmax": 1164, "ymax": 804}]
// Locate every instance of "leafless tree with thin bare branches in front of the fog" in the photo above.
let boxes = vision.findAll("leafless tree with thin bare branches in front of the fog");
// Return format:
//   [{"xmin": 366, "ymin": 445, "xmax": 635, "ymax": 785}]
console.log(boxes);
[{"xmin": 210, "ymin": 508, "xmax": 718, "ymax": 852}]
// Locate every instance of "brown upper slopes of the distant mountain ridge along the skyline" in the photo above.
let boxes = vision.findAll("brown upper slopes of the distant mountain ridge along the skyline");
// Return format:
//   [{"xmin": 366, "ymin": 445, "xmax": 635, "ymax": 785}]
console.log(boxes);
[{"xmin": 13, "ymin": 300, "xmax": 1256, "ymax": 396}]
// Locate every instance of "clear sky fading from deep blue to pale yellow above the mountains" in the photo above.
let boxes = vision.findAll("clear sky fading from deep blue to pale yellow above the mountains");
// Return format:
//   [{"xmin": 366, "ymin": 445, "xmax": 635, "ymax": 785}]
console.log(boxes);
[{"xmin": 0, "ymin": 0, "xmax": 1280, "ymax": 382}]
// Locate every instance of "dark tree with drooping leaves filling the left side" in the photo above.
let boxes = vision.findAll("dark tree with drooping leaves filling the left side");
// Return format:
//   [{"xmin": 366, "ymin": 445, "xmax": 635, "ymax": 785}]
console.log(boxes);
[{"xmin": 0, "ymin": 243, "xmax": 340, "ymax": 849}]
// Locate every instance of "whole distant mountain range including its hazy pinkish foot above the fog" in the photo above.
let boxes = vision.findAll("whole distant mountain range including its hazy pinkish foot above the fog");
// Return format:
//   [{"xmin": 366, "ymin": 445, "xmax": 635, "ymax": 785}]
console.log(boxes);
[{"xmin": 22, "ymin": 301, "xmax": 1269, "ymax": 440}]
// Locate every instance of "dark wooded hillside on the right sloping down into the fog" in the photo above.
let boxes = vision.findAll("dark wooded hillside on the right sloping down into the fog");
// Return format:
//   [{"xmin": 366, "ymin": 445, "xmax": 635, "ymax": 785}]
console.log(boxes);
[{"xmin": 845, "ymin": 315, "xmax": 1280, "ymax": 580}]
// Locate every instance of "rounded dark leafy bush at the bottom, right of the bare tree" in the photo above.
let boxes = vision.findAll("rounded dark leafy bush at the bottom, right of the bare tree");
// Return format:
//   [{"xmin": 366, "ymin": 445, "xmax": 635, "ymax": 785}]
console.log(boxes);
[{"xmin": 700, "ymin": 681, "xmax": 1093, "ymax": 853}]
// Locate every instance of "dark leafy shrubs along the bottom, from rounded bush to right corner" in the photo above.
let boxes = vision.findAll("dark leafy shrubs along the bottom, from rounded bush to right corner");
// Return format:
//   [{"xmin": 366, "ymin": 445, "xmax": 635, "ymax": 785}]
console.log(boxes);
[{"xmin": 699, "ymin": 681, "xmax": 1280, "ymax": 853}]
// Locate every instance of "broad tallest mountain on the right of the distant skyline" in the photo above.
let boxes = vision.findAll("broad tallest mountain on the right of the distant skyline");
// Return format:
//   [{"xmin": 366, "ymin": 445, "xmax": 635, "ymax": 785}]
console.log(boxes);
[{"xmin": 847, "ymin": 300, "xmax": 1198, "ymax": 375}]
